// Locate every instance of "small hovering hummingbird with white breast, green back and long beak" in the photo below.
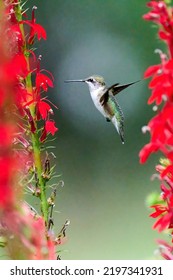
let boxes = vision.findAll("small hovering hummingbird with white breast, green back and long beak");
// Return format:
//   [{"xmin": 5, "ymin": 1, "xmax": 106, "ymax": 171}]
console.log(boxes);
[{"xmin": 65, "ymin": 75, "xmax": 138, "ymax": 144}]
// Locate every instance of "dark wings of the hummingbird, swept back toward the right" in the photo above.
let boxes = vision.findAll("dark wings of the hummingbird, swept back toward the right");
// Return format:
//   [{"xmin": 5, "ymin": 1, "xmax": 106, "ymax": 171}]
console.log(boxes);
[{"xmin": 100, "ymin": 81, "xmax": 139, "ymax": 105}]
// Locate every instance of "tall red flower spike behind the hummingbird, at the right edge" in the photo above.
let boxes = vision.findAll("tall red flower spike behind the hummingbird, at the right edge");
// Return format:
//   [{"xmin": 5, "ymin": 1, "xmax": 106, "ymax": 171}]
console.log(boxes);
[{"xmin": 139, "ymin": 1, "xmax": 173, "ymax": 259}]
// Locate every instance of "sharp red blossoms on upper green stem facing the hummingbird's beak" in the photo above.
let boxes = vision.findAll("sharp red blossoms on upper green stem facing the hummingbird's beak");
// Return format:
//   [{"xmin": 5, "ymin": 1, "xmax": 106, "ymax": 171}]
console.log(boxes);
[{"xmin": 6, "ymin": 1, "xmax": 58, "ymax": 140}]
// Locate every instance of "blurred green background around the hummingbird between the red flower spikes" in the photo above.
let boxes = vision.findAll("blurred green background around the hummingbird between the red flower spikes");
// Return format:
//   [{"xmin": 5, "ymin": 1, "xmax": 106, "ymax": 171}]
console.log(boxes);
[{"xmin": 27, "ymin": 0, "xmax": 164, "ymax": 259}]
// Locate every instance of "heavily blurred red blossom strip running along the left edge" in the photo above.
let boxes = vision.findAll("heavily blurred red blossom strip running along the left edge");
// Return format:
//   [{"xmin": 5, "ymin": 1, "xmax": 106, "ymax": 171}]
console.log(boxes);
[{"xmin": 0, "ymin": 3, "xmax": 17, "ymax": 211}]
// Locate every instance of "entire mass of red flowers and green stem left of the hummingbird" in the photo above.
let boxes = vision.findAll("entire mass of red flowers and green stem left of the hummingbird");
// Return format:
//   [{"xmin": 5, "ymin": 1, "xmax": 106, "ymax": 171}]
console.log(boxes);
[{"xmin": 0, "ymin": 0, "xmax": 65, "ymax": 259}]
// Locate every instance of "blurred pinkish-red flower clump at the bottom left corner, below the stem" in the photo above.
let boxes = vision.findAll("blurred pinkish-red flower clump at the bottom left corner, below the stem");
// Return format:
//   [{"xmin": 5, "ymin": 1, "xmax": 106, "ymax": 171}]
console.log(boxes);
[{"xmin": 3, "ymin": 204, "xmax": 56, "ymax": 260}]
